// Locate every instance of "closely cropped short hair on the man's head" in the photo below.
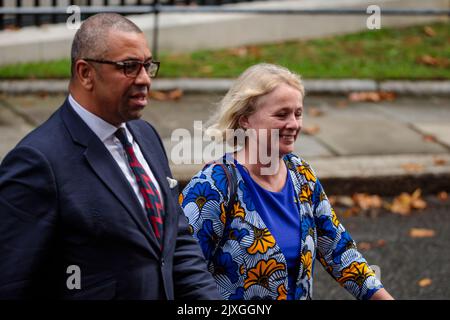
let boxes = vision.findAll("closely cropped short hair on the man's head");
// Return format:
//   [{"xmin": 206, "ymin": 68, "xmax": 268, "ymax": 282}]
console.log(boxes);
[{"xmin": 70, "ymin": 13, "xmax": 142, "ymax": 78}]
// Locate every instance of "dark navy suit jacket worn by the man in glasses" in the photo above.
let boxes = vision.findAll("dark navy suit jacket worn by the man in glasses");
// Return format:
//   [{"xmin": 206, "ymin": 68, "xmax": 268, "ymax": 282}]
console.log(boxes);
[{"xmin": 0, "ymin": 100, "xmax": 219, "ymax": 299}]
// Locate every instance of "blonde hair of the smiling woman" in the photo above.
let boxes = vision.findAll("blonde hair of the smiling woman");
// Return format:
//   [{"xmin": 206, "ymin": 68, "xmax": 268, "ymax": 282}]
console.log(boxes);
[{"xmin": 206, "ymin": 63, "xmax": 305, "ymax": 145}]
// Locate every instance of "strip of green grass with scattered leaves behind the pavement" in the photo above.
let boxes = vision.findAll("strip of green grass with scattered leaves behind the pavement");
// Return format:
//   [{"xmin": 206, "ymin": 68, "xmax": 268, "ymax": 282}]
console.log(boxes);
[{"xmin": 0, "ymin": 22, "xmax": 450, "ymax": 80}]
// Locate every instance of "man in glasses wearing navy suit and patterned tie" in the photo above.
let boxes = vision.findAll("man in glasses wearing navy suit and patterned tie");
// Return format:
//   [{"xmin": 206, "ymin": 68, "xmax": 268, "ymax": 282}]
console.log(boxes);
[{"xmin": 0, "ymin": 14, "xmax": 219, "ymax": 299}]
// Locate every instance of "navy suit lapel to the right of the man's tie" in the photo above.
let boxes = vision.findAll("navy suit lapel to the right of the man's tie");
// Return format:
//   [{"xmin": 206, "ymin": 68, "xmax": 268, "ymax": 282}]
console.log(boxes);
[{"xmin": 127, "ymin": 122, "xmax": 176, "ymax": 255}]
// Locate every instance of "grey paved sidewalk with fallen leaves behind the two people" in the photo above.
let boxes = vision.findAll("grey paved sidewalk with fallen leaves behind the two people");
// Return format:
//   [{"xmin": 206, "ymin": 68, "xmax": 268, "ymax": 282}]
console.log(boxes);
[{"xmin": 0, "ymin": 93, "xmax": 450, "ymax": 195}]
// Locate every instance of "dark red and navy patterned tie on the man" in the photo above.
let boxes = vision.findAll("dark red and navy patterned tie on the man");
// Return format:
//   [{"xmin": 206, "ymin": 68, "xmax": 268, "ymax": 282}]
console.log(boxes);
[{"xmin": 115, "ymin": 128, "xmax": 164, "ymax": 249}]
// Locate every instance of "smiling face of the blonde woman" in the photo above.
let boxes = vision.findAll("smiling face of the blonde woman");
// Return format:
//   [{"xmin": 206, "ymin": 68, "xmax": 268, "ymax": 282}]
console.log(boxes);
[{"xmin": 240, "ymin": 83, "xmax": 303, "ymax": 157}]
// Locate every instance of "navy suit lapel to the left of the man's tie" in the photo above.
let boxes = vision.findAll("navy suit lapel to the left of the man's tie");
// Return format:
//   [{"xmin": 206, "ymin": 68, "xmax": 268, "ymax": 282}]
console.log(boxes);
[{"xmin": 61, "ymin": 100, "xmax": 159, "ymax": 252}]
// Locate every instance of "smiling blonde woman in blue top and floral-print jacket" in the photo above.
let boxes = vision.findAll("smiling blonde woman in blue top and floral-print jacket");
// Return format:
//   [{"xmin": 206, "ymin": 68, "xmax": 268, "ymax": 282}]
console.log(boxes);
[{"xmin": 180, "ymin": 64, "xmax": 392, "ymax": 300}]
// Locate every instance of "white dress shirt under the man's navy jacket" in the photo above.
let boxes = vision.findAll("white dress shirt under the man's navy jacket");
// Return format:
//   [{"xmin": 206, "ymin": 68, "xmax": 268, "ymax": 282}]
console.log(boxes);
[{"xmin": 69, "ymin": 95, "xmax": 164, "ymax": 208}]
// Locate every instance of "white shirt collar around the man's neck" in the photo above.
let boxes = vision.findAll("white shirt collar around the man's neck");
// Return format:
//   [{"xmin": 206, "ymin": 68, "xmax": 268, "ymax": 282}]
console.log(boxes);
[{"xmin": 68, "ymin": 94, "xmax": 124, "ymax": 142}]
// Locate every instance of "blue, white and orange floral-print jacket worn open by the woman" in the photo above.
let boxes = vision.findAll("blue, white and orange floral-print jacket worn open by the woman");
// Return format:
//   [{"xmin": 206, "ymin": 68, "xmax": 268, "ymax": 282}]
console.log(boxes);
[{"xmin": 179, "ymin": 154, "xmax": 382, "ymax": 300}]
